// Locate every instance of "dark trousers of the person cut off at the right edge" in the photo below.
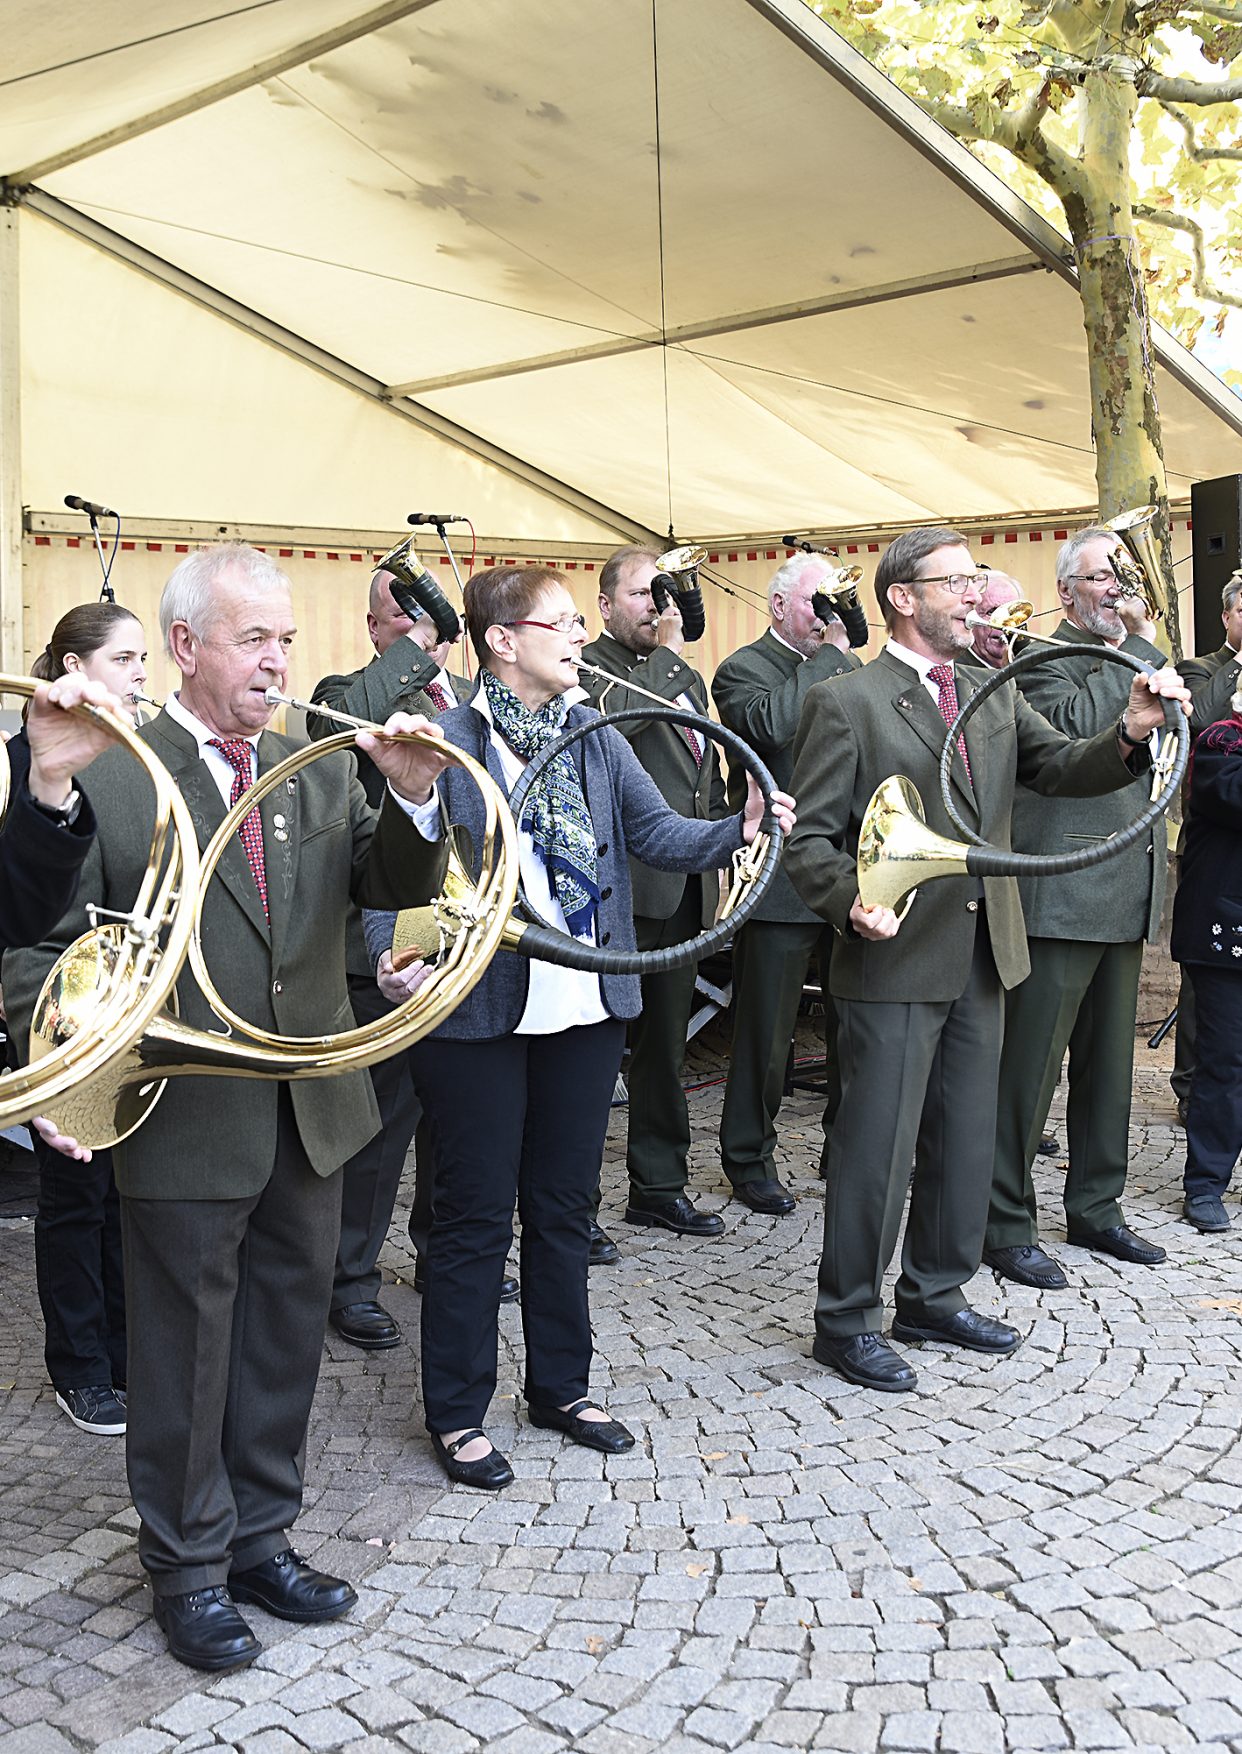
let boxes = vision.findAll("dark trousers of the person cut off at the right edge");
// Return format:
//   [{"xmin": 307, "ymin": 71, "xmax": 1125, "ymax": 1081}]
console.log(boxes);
[{"xmin": 1182, "ymin": 963, "xmax": 1242, "ymax": 1200}]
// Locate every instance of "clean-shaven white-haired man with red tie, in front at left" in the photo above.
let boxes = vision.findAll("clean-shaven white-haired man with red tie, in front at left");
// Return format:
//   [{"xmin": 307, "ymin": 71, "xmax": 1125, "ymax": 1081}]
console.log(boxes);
[{"xmin": 4, "ymin": 544, "xmax": 444, "ymax": 1670}]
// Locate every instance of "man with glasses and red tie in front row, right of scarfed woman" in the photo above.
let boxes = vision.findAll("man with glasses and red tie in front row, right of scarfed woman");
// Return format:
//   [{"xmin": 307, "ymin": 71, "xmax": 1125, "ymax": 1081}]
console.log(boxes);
[{"xmin": 786, "ymin": 528, "xmax": 1188, "ymax": 1389}]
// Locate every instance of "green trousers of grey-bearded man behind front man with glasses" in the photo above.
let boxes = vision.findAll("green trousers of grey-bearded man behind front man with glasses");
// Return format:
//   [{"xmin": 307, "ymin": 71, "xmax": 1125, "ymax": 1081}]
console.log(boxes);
[{"xmin": 986, "ymin": 938, "xmax": 1142, "ymax": 1249}]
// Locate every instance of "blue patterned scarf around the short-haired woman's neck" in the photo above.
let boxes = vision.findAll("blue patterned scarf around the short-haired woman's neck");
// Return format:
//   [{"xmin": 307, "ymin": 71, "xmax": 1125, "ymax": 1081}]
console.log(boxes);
[{"xmin": 481, "ymin": 670, "xmax": 600, "ymax": 938}]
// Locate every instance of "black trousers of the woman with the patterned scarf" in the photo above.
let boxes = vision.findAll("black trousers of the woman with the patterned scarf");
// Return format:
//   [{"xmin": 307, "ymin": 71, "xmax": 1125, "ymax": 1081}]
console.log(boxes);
[{"xmin": 410, "ymin": 1019, "xmax": 625, "ymax": 1431}]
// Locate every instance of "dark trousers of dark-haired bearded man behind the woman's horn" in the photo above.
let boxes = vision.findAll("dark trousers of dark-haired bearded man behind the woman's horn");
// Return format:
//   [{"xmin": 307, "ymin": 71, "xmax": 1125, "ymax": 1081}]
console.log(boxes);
[{"xmin": 626, "ymin": 877, "xmax": 703, "ymax": 1200}]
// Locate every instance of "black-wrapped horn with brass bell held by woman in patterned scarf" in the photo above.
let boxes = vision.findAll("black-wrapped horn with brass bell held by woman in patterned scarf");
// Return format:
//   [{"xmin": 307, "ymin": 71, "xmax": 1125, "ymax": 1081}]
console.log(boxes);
[{"xmin": 393, "ymin": 705, "xmax": 782, "ymax": 975}]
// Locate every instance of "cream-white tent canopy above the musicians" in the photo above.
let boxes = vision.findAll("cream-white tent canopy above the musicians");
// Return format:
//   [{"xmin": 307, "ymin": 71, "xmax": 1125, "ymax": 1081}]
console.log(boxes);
[{"xmin": 0, "ymin": 0, "xmax": 1242, "ymax": 652}]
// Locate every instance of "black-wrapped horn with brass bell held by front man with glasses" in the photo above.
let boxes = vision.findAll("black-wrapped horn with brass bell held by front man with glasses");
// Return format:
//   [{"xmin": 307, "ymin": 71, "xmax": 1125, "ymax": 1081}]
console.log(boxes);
[{"xmin": 858, "ymin": 640, "xmax": 1189, "ymax": 917}]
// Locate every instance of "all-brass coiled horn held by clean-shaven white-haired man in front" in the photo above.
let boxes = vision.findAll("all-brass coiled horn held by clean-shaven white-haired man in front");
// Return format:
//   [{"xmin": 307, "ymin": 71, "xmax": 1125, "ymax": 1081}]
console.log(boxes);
[{"xmin": 26, "ymin": 700, "xmax": 518, "ymax": 1147}]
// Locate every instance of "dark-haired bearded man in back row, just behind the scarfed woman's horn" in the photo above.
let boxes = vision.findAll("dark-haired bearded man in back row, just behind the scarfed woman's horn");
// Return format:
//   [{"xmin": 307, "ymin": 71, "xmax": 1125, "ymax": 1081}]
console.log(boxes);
[{"xmin": 582, "ymin": 547, "xmax": 728, "ymax": 1259}]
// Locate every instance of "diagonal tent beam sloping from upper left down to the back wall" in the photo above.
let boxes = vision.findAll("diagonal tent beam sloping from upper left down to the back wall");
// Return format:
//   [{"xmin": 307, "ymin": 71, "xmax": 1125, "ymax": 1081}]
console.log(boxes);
[{"xmin": 21, "ymin": 188, "xmax": 663, "ymax": 545}]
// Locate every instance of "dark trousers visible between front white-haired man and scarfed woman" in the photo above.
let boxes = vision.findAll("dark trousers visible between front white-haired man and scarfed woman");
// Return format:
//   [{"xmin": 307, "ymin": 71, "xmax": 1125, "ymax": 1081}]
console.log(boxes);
[{"xmin": 332, "ymin": 975, "xmax": 419, "ymax": 1310}]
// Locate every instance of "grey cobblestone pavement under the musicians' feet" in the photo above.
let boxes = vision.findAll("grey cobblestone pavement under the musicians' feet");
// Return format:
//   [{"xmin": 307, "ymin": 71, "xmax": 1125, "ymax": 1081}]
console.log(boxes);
[{"xmin": 0, "ymin": 1024, "xmax": 1242, "ymax": 1754}]
